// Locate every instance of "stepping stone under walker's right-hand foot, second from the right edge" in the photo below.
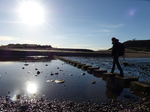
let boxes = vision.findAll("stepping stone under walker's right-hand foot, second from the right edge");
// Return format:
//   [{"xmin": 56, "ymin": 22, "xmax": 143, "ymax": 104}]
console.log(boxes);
[{"xmin": 116, "ymin": 75, "xmax": 138, "ymax": 88}]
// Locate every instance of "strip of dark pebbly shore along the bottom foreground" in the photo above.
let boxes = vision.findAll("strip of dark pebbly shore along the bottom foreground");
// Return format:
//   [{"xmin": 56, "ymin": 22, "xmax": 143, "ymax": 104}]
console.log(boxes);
[{"xmin": 0, "ymin": 96, "xmax": 150, "ymax": 112}]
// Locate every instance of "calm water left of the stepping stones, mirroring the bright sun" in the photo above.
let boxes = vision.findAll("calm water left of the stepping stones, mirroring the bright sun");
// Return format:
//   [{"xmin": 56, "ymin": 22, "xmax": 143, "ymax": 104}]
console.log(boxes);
[{"xmin": 0, "ymin": 59, "xmax": 139, "ymax": 102}]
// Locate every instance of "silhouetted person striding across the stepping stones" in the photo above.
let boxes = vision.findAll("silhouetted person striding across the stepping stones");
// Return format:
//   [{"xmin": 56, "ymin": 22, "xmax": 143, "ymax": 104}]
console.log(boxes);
[{"xmin": 111, "ymin": 37, "xmax": 124, "ymax": 77}]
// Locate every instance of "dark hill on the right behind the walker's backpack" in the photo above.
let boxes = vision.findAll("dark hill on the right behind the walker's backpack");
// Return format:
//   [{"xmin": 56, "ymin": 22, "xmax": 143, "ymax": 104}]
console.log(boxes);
[{"xmin": 123, "ymin": 39, "xmax": 150, "ymax": 52}]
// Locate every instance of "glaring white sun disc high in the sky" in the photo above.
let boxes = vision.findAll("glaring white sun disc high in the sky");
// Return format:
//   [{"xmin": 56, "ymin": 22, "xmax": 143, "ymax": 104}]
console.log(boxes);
[{"xmin": 19, "ymin": 1, "xmax": 45, "ymax": 25}]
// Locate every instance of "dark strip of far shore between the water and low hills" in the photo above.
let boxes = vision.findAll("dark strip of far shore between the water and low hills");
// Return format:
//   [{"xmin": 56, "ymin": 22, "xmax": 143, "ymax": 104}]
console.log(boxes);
[{"xmin": 0, "ymin": 49, "xmax": 150, "ymax": 59}]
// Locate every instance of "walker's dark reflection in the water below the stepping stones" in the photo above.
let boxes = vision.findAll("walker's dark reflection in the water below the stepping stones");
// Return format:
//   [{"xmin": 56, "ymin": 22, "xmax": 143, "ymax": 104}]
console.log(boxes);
[{"xmin": 105, "ymin": 76, "xmax": 123, "ymax": 99}]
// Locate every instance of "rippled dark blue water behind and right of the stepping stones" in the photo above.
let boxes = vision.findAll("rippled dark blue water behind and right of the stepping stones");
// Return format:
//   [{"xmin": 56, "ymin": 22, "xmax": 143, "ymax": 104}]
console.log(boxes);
[{"xmin": 64, "ymin": 57, "xmax": 150, "ymax": 81}]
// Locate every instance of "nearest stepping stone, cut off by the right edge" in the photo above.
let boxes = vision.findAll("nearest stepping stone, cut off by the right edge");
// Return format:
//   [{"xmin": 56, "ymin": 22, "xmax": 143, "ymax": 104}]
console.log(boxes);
[{"xmin": 130, "ymin": 81, "xmax": 150, "ymax": 96}]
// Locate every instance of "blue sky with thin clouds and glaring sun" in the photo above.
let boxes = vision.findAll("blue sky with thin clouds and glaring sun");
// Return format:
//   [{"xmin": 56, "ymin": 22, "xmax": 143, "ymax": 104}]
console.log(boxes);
[{"xmin": 0, "ymin": 0, "xmax": 150, "ymax": 50}]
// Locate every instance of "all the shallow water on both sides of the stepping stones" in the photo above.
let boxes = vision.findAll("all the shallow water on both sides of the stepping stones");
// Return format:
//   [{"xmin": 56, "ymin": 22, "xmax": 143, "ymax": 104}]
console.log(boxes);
[{"xmin": 0, "ymin": 57, "xmax": 150, "ymax": 103}]
